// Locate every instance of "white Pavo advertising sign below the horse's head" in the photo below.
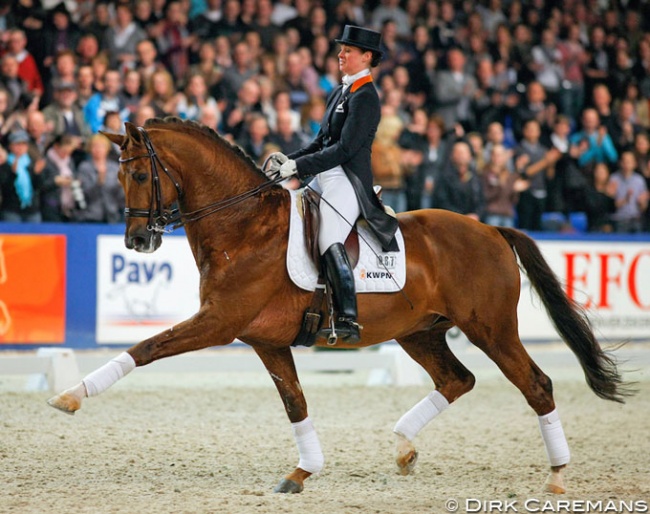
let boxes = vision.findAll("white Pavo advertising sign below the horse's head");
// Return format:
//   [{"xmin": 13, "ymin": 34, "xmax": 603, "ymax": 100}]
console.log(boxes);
[{"xmin": 96, "ymin": 235, "xmax": 199, "ymax": 344}]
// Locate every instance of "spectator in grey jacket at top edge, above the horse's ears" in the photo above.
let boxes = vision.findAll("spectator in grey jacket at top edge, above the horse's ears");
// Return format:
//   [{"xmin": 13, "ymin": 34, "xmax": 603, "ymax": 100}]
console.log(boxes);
[{"xmin": 101, "ymin": 2, "xmax": 147, "ymax": 71}]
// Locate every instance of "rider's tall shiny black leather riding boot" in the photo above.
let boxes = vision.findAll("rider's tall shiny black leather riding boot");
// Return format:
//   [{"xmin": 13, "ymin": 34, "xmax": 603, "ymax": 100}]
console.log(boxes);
[{"xmin": 323, "ymin": 243, "xmax": 361, "ymax": 343}]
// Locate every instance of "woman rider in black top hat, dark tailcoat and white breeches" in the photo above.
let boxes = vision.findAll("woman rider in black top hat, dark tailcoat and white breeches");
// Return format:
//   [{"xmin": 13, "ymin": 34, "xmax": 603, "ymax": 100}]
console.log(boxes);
[{"xmin": 269, "ymin": 25, "xmax": 398, "ymax": 343}]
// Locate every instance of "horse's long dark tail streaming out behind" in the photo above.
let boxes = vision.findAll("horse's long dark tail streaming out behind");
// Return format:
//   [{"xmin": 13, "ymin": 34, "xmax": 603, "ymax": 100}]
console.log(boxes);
[{"xmin": 497, "ymin": 227, "xmax": 634, "ymax": 403}]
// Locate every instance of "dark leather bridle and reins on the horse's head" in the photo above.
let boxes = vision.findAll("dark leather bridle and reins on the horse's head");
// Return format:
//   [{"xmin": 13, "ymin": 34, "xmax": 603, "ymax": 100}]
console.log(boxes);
[{"xmin": 119, "ymin": 127, "xmax": 283, "ymax": 233}]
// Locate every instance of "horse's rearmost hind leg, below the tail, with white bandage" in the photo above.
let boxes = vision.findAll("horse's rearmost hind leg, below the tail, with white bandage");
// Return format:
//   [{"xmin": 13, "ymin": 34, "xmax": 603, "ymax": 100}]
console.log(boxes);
[{"xmin": 467, "ymin": 325, "xmax": 570, "ymax": 494}]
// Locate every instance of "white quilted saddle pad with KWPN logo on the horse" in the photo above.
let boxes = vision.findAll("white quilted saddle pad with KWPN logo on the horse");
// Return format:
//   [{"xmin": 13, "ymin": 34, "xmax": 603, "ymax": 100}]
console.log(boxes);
[{"xmin": 287, "ymin": 191, "xmax": 406, "ymax": 293}]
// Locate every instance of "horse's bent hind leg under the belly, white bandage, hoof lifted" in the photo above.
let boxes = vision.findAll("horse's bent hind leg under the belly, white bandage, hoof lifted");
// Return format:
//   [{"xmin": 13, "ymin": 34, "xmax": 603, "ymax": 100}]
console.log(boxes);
[{"xmin": 393, "ymin": 321, "xmax": 475, "ymax": 475}]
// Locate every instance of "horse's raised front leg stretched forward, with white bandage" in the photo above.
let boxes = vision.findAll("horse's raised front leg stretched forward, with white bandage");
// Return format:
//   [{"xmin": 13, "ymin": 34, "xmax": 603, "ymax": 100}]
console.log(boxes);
[{"xmin": 47, "ymin": 311, "xmax": 235, "ymax": 414}]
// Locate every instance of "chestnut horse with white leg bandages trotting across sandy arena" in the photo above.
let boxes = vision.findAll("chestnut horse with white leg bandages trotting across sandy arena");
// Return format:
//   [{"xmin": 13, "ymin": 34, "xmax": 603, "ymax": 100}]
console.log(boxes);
[{"xmin": 49, "ymin": 119, "xmax": 630, "ymax": 492}]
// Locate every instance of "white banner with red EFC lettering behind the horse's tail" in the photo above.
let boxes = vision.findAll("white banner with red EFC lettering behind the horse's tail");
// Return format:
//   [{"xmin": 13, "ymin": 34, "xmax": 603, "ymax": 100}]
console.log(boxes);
[{"xmin": 518, "ymin": 241, "xmax": 650, "ymax": 340}]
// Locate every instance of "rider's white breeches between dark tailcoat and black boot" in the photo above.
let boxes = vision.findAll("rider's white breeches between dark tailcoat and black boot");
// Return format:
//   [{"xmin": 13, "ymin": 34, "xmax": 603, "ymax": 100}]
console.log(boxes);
[{"xmin": 309, "ymin": 166, "xmax": 361, "ymax": 255}]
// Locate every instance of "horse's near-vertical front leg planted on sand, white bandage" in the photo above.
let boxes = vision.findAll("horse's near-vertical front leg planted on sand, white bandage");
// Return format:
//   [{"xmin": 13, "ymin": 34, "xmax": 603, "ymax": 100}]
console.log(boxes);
[{"xmin": 254, "ymin": 346, "xmax": 325, "ymax": 493}]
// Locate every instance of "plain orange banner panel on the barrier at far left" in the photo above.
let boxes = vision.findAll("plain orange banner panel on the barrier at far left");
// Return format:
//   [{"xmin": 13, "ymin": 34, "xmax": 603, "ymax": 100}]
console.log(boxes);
[{"xmin": 0, "ymin": 234, "xmax": 66, "ymax": 344}]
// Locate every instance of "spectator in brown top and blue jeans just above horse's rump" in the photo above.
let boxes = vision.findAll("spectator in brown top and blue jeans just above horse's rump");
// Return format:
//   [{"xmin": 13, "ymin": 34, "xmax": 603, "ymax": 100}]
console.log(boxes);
[{"xmin": 480, "ymin": 144, "xmax": 530, "ymax": 227}]
